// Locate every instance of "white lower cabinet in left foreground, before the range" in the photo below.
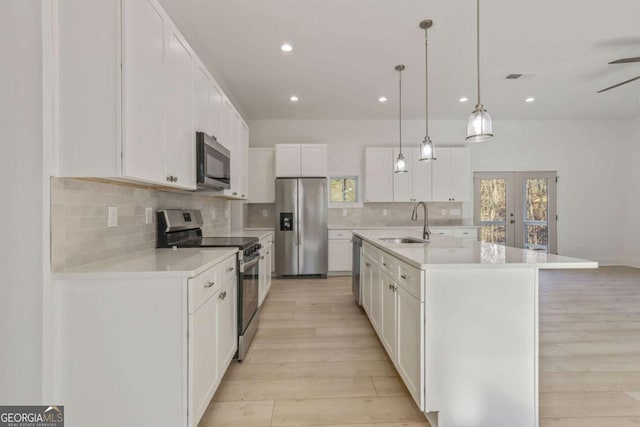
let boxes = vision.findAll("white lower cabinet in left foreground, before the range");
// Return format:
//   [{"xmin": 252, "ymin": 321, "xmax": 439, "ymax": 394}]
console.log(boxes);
[{"xmin": 53, "ymin": 249, "xmax": 237, "ymax": 427}]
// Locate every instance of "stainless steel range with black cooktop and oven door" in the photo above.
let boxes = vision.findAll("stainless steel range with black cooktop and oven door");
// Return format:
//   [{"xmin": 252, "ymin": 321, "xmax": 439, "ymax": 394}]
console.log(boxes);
[{"xmin": 158, "ymin": 209, "xmax": 261, "ymax": 360}]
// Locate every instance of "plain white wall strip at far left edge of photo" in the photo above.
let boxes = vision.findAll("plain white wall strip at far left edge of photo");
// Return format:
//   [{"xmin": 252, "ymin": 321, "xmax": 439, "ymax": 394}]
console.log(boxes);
[{"xmin": 0, "ymin": 0, "xmax": 44, "ymax": 404}]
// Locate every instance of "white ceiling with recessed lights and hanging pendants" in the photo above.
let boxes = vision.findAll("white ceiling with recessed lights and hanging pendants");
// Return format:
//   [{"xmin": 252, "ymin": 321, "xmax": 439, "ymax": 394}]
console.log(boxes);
[{"xmin": 160, "ymin": 0, "xmax": 640, "ymax": 120}]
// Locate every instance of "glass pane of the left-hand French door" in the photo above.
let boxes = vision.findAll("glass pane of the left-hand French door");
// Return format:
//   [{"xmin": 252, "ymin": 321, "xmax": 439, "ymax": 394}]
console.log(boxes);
[{"xmin": 480, "ymin": 178, "xmax": 507, "ymax": 244}]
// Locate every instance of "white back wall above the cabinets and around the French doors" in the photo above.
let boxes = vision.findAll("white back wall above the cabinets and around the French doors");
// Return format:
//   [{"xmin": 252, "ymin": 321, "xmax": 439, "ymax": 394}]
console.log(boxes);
[{"xmin": 250, "ymin": 120, "xmax": 628, "ymax": 264}]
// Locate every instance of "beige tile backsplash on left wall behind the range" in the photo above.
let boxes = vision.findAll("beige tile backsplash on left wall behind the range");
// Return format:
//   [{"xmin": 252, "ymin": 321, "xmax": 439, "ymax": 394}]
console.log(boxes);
[{"xmin": 51, "ymin": 178, "xmax": 230, "ymax": 272}]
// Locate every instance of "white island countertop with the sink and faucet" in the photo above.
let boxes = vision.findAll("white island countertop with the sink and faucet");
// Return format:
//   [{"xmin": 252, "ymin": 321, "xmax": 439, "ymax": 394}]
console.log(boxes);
[{"xmin": 354, "ymin": 231, "xmax": 598, "ymax": 270}]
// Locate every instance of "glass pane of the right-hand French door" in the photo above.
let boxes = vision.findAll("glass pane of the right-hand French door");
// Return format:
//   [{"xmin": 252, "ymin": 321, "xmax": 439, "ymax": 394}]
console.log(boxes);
[{"xmin": 523, "ymin": 178, "xmax": 549, "ymax": 251}]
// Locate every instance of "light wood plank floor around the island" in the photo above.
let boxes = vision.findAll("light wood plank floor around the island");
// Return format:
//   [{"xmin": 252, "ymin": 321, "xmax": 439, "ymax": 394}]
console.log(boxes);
[{"xmin": 199, "ymin": 267, "xmax": 640, "ymax": 427}]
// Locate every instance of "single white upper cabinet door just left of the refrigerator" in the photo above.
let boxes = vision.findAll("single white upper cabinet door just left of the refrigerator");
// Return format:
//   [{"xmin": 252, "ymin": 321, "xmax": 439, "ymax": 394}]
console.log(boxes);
[{"xmin": 249, "ymin": 148, "xmax": 276, "ymax": 203}]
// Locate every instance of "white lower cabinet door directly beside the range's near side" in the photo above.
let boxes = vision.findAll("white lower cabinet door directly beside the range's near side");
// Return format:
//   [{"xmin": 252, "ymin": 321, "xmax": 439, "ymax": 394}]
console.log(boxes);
[{"xmin": 218, "ymin": 275, "xmax": 238, "ymax": 377}]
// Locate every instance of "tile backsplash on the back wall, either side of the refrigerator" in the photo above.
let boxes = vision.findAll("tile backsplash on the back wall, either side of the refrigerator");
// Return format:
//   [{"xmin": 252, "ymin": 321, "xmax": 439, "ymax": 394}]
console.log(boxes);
[{"xmin": 244, "ymin": 202, "xmax": 463, "ymax": 228}]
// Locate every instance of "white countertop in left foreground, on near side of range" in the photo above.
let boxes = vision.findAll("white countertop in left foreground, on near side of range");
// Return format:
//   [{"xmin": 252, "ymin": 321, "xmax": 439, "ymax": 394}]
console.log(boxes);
[{"xmin": 53, "ymin": 248, "xmax": 238, "ymax": 279}]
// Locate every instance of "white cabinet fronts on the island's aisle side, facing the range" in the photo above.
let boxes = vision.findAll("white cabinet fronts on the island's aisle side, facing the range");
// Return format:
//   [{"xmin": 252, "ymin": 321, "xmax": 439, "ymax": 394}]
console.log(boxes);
[{"xmin": 361, "ymin": 242, "xmax": 425, "ymax": 410}]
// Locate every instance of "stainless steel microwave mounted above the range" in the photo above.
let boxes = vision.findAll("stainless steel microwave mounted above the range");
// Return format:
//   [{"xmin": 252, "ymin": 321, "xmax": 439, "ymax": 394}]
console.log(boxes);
[{"xmin": 196, "ymin": 132, "xmax": 231, "ymax": 190}]
